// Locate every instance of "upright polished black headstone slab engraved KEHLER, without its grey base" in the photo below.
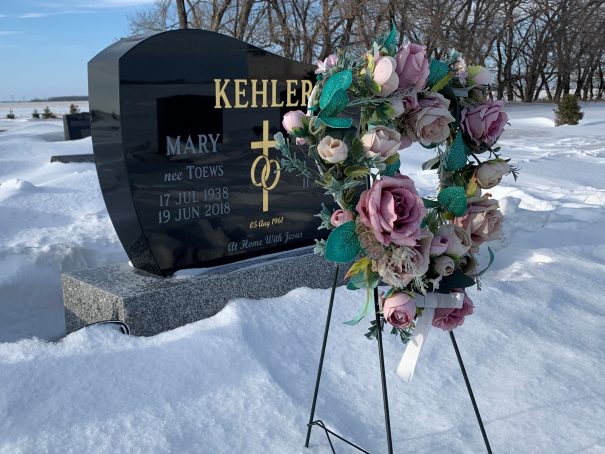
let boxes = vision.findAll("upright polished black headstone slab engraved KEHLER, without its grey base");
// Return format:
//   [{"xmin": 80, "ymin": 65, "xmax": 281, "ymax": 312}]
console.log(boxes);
[{"xmin": 88, "ymin": 30, "xmax": 331, "ymax": 275}]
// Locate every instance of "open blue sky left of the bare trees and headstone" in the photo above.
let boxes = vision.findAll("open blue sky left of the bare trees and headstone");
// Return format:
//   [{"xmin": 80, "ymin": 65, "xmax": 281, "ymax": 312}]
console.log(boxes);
[{"xmin": 0, "ymin": 0, "xmax": 153, "ymax": 101}]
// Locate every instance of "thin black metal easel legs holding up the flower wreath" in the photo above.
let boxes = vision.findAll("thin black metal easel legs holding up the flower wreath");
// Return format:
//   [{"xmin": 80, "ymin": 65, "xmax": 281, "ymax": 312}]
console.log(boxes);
[{"xmin": 305, "ymin": 264, "xmax": 492, "ymax": 454}]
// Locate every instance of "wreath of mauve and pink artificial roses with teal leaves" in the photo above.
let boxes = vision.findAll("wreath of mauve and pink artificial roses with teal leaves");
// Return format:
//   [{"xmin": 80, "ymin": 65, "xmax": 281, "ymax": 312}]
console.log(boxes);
[{"xmin": 275, "ymin": 26, "xmax": 517, "ymax": 343}]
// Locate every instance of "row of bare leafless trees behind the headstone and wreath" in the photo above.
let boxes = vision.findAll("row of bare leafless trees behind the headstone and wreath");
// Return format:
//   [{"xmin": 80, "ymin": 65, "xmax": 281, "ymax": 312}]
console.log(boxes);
[{"xmin": 128, "ymin": 0, "xmax": 605, "ymax": 102}]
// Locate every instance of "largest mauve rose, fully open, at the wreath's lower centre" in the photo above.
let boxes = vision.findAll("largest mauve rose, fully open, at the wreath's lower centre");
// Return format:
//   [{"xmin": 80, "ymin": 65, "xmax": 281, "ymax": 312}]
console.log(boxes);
[{"xmin": 356, "ymin": 174, "xmax": 426, "ymax": 246}]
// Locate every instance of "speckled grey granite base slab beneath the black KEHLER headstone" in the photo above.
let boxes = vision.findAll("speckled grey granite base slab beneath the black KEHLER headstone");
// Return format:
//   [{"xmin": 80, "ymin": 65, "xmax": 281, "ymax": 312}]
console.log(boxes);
[{"xmin": 61, "ymin": 247, "xmax": 347, "ymax": 336}]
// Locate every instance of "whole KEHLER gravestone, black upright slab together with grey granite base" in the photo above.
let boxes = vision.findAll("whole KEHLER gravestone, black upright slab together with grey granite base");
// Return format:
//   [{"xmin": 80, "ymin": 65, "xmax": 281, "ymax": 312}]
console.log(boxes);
[{"xmin": 63, "ymin": 30, "xmax": 342, "ymax": 335}]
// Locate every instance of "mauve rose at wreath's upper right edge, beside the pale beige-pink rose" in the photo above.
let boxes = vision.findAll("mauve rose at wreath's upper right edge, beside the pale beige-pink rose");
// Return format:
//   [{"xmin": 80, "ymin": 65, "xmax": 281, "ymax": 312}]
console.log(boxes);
[{"xmin": 460, "ymin": 101, "xmax": 508, "ymax": 147}]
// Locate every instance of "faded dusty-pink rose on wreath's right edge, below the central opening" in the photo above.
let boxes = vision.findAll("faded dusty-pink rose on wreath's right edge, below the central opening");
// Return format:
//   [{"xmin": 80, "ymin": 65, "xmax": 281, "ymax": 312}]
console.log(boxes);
[{"xmin": 454, "ymin": 194, "xmax": 504, "ymax": 252}]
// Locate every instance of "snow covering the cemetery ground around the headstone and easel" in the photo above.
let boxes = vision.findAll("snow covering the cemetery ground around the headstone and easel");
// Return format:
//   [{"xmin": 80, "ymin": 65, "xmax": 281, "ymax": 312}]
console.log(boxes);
[{"xmin": 0, "ymin": 104, "xmax": 605, "ymax": 454}]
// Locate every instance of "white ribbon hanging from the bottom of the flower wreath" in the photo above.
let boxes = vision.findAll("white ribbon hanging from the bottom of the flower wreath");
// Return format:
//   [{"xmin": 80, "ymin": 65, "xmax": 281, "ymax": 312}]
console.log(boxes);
[{"xmin": 397, "ymin": 293, "xmax": 464, "ymax": 383}]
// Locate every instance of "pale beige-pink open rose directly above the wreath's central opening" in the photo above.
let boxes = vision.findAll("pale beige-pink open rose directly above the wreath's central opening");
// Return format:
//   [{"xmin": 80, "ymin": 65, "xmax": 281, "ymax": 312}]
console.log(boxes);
[{"xmin": 406, "ymin": 93, "xmax": 456, "ymax": 145}]
